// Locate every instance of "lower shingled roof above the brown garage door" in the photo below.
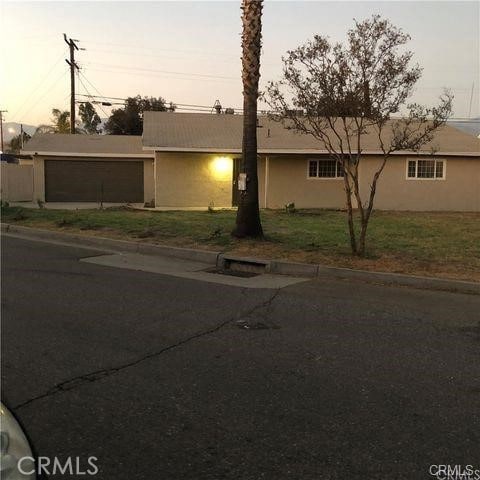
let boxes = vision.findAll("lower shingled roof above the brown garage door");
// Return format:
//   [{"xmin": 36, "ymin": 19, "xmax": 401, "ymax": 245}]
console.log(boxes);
[{"xmin": 22, "ymin": 133, "xmax": 151, "ymax": 157}]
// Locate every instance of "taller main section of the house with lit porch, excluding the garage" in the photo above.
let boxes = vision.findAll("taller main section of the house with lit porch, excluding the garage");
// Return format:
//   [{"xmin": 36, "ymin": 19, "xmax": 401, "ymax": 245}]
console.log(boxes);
[{"xmin": 143, "ymin": 112, "xmax": 480, "ymax": 211}]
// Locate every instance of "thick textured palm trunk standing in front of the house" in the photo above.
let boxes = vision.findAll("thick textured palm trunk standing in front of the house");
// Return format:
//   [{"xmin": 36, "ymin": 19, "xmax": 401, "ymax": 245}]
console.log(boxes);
[{"xmin": 232, "ymin": 0, "xmax": 263, "ymax": 238}]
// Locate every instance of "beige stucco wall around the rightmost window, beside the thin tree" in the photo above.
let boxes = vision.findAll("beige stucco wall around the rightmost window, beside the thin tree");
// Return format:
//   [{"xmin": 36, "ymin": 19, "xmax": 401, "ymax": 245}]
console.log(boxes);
[{"xmin": 359, "ymin": 156, "xmax": 480, "ymax": 212}]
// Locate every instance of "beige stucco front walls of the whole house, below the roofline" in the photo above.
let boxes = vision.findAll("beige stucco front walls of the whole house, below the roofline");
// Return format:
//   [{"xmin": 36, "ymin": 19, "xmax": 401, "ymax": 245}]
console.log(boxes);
[{"xmin": 34, "ymin": 152, "xmax": 472, "ymax": 211}]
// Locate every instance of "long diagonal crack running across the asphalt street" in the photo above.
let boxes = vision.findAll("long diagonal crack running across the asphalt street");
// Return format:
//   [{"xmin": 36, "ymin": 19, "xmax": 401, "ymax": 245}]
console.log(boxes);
[{"xmin": 12, "ymin": 288, "xmax": 280, "ymax": 410}]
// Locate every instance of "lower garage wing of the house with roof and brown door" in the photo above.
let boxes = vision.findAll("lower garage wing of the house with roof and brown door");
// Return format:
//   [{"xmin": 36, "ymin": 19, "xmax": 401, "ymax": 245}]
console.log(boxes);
[{"xmin": 22, "ymin": 134, "xmax": 154, "ymax": 204}]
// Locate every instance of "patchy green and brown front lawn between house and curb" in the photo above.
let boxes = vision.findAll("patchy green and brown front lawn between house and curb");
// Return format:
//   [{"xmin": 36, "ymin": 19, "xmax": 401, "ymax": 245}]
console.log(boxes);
[{"xmin": 2, "ymin": 207, "xmax": 480, "ymax": 281}]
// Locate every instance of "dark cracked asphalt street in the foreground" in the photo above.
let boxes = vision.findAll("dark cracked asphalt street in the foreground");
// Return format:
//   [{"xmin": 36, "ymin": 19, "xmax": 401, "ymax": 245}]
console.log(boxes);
[{"xmin": 2, "ymin": 237, "xmax": 480, "ymax": 480}]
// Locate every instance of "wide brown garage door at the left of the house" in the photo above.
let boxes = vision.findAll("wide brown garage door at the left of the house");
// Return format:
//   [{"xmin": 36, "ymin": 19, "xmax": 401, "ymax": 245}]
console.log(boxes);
[{"xmin": 45, "ymin": 160, "xmax": 143, "ymax": 203}]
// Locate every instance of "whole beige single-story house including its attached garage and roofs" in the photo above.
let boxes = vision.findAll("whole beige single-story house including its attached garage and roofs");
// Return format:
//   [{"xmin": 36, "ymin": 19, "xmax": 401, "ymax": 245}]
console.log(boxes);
[{"xmin": 23, "ymin": 112, "xmax": 480, "ymax": 211}]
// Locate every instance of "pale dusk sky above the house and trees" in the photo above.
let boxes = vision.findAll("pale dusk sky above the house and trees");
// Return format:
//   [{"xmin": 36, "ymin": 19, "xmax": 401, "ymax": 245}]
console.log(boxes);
[{"xmin": 0, "ymin": 0, "xmax": 480, "ymax": 125}]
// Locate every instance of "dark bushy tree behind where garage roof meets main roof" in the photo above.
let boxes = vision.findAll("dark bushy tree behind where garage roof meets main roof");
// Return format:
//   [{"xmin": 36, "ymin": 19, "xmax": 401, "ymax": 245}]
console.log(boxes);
[{"xmin": 105, "ymin": 95, "xmax": 175, "ymax": 135}]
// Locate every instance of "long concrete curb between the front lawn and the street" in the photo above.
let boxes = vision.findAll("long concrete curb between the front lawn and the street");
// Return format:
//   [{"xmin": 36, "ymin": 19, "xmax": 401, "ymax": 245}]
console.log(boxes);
[{"xmin": 1, "ymin": 223, "xmax": 480, "ymax": 295}]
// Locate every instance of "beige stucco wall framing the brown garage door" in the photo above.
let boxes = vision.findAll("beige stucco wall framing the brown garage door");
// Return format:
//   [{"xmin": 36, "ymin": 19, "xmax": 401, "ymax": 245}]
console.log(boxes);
[{"xmin": 33, "ymin": 155, "xmax": 155, "ymax": 202}]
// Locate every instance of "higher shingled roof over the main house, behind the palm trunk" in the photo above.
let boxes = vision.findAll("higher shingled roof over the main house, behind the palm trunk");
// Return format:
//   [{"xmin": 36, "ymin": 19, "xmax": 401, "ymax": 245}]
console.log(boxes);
[{"xmin": 143, "ymin": 112, "xmax": 480, "ymax": 156}]
